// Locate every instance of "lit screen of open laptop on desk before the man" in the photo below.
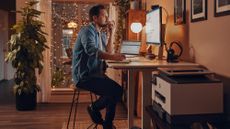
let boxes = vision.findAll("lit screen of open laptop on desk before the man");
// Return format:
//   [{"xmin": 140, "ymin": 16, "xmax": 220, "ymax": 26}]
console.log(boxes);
[{"xmin": 121, "ymin": 41, "xmax": 141, "ymax": 55}]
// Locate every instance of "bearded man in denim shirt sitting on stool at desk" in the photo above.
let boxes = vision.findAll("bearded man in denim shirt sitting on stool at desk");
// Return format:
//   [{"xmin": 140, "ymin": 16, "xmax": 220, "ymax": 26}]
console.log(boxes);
[{"xmin": 72, "ymin": 5, "xmax": 125, "ymax": 129}]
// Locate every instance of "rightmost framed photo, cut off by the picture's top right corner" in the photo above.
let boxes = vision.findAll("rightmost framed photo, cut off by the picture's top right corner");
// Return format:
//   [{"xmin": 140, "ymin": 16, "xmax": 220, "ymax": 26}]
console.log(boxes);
[{"xmin": 214, "ymin": 0, "xmax": 230, "ymax": 17}]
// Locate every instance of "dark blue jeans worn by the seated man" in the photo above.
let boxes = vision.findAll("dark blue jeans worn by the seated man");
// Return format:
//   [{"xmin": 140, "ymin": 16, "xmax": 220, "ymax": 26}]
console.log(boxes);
[{"xmin": 77, "ymin": 76, "xmax": 123, "ymax": 124}]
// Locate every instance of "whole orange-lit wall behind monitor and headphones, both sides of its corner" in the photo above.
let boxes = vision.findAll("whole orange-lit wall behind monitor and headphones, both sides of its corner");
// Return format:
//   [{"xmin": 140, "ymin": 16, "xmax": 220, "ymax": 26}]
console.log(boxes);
[{"xmin": 146, "ymin": 0, "xmax": 230, "ymax": 121}]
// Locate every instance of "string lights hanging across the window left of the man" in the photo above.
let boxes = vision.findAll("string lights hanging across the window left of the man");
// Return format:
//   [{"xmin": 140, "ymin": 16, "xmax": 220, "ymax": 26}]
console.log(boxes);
[{"xmin": 50, "ymin": 2, "xmax": 95, "ymax": 86}]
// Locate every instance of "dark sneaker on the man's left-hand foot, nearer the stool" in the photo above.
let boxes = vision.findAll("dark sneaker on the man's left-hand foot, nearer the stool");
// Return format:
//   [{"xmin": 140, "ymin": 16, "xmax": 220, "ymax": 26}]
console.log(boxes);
[{"xmin": 87, "ymin": 106, "xmax": 103, "ymax": 124}]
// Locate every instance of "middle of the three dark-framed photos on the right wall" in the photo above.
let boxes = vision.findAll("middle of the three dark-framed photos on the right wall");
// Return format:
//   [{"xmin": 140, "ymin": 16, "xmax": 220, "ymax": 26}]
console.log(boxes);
[{"xmin": 191, "ymin": 0, "xmax": 207, "ymax": 22}]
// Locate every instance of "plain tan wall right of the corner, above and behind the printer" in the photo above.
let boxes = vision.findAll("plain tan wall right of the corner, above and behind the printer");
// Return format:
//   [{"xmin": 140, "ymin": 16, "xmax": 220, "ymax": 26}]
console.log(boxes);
[{"xmin": 187, "ymin": 1, "xmax": 230, "ymax": 121}]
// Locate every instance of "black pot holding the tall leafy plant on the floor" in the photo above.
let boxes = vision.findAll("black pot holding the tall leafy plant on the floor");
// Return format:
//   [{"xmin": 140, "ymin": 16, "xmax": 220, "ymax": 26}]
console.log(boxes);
[{"xmin": 16, "ymin": 91, "xmax": 37, "ymax": 111}]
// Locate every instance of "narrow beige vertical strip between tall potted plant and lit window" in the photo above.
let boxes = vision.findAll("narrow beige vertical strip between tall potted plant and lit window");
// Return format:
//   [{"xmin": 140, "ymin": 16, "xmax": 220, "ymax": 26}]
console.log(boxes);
[{"xmin": 36, "ymin": 0, "xmax": 52, "ymax": 102}]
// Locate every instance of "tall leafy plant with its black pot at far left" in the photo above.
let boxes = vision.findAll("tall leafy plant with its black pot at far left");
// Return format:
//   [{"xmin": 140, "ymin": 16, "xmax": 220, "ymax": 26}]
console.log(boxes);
[{"xmin": 5, "ymin": 1, "xmax": 48, "ymax": 110}]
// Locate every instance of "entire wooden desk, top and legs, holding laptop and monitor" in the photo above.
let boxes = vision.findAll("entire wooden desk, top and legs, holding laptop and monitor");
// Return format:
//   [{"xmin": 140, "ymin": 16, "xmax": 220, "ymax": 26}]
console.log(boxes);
[{"xmin": 108, "ymin": 57, "xmax": 199, "ymax": 129}]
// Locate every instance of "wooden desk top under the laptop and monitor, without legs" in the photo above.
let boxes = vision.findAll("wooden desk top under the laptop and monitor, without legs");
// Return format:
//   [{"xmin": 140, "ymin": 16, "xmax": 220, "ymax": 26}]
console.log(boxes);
[{"xmin": 108, "ymin": 57, "xmax": 199, "ymax": 69}]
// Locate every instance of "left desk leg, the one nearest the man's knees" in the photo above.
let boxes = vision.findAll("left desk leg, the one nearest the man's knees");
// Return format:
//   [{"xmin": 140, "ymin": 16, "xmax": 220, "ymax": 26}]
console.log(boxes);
[{"xmin": 128, "ymin": 70, "xmax": 135, "ymax": 129}]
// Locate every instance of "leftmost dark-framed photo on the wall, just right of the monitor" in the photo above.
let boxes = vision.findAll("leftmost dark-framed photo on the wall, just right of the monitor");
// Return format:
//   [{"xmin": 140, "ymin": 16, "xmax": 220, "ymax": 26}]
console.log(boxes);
[{"xmin": 174, "ymin": 0, "xmax": 186, "ymax": 25}]
